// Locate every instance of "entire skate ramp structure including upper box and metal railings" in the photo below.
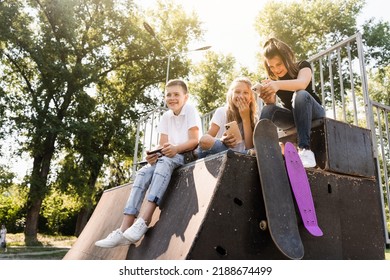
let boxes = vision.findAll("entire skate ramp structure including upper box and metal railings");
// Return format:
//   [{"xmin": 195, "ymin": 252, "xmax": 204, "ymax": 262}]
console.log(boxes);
[{"xmin": 64, "ymin": 34, "xmax": 390, "ymax": 260}]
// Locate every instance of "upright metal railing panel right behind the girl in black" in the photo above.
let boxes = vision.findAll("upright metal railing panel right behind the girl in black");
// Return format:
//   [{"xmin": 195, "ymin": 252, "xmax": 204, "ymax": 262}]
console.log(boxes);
[{"xmin": 309, "ymin": 33, "xmax": 371, "ymax": 128}]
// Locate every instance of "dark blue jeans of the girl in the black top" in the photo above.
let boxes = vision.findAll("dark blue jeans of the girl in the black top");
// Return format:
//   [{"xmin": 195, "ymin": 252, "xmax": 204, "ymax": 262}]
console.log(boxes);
[{"xmin": 260, "ymin": 90, "xmax": 325, "ymax": 149}]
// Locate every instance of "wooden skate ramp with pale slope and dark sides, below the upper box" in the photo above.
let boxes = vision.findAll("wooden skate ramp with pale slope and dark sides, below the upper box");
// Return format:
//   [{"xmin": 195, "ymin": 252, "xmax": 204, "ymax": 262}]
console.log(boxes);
[{"xmin": 64, "ymin": 151, "xmax": 384, "ymax": 260}]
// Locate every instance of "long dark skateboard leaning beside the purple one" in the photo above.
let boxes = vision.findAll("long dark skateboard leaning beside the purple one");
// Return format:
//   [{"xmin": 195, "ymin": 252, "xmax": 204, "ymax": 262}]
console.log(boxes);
[{"xmin": 253, "ymin": 119, "xmax": 304, "ymax": 259}]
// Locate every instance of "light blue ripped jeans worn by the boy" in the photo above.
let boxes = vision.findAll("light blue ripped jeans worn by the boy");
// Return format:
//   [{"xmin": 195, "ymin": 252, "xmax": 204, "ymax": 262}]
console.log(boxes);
[{"xmin": 123, "ymin": 154, "xmax": 184, "ymax": 216}]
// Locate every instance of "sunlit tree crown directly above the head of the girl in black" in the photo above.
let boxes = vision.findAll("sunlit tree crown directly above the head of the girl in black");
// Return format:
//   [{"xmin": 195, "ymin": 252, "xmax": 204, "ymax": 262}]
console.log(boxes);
[{"xmin": 255, "ymin": 0, "xmax": 365, "ymax": 59}]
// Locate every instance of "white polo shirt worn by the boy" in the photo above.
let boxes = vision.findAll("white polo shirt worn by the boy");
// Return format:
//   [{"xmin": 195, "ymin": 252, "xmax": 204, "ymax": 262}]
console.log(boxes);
[{"xmin": 157, "ymin": 103, "xmax": 202, "ymax": 145}]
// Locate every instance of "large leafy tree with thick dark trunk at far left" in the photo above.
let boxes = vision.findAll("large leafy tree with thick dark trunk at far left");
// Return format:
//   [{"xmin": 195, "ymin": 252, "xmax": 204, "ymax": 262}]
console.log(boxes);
[{"xmin": 0, "ymin": 0, "xmax": 201, "ymax": 243}]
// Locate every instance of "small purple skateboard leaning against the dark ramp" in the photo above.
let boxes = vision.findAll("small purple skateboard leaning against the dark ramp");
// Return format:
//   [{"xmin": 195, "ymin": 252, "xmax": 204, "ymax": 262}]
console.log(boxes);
[{"xmin": 284, "ymin": 142, "xmax": 323, "ymax": 236}]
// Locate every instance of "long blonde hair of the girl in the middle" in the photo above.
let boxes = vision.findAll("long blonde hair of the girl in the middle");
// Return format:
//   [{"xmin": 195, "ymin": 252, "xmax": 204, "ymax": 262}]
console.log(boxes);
[{"xmin": 226, "ymin": 77, "xmax": 257, "ymax": 128}]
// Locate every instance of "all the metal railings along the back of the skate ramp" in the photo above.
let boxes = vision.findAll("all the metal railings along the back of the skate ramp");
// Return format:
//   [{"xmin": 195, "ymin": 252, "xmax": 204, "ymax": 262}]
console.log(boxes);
[{"xmin": 133, "ymin": 33, "xmax": 390, "ymax": 244}]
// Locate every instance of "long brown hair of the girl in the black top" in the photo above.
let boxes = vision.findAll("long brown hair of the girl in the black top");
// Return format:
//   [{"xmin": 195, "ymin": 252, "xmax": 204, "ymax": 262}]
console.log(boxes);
[{"xmin": 263, "ymin": 38, "xmax": 299, "ymax": 80}]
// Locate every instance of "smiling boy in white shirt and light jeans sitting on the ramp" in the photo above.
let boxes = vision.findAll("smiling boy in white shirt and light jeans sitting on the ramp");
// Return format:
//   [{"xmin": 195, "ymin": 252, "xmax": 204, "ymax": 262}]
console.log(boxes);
[{"xmin": 95, "ymin": 79, "xmax": 201, "ymax": 248}]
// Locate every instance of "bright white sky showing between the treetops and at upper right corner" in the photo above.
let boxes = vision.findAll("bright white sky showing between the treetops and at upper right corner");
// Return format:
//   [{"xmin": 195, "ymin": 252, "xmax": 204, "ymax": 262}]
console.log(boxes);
[{"xmin": 136, "ymin": 0, "xmax": 390, "ymax": 71}]
